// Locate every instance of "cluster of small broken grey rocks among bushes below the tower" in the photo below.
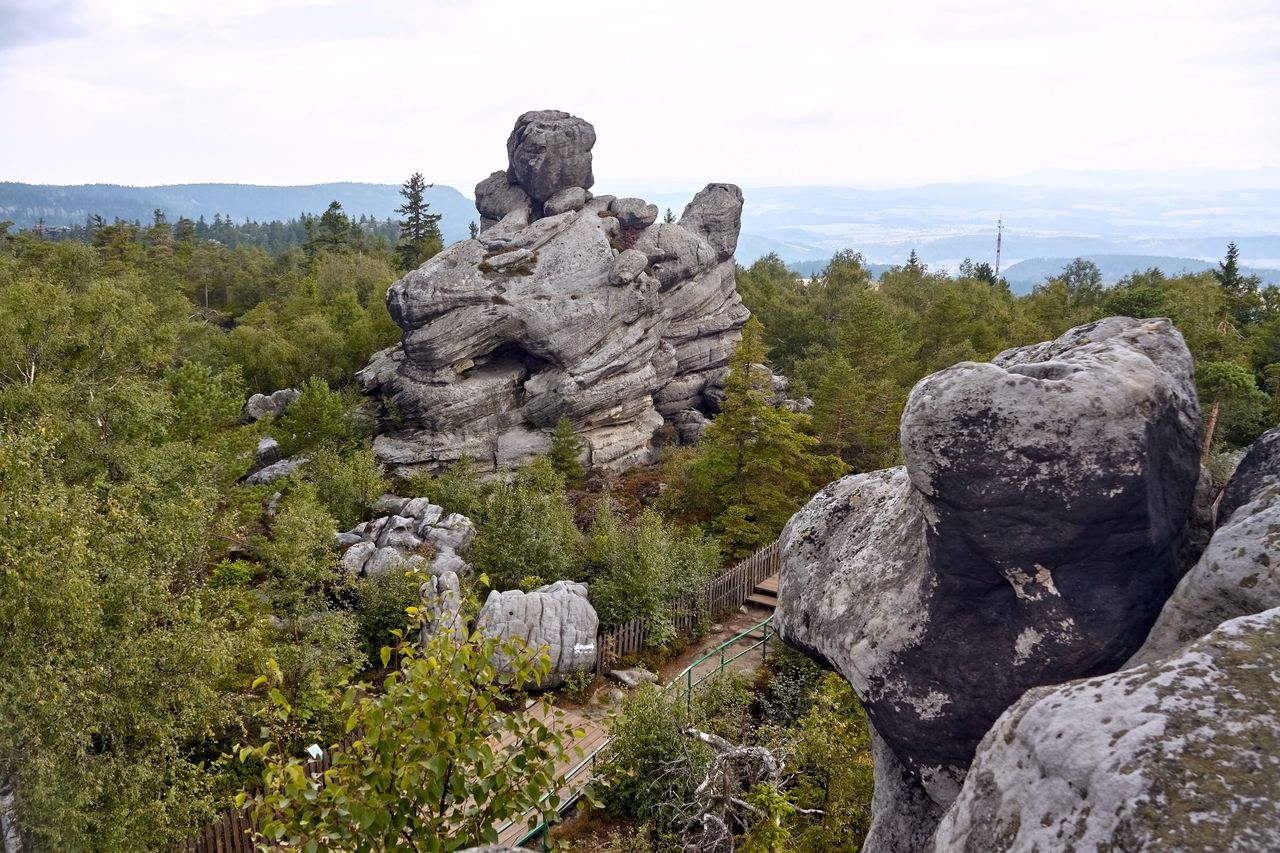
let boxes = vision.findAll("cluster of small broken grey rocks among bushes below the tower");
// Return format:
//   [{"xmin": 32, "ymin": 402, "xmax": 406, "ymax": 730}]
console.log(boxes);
[{"xmin": 338, "ymin": 494, "xmax": 475, "ymax": 578}]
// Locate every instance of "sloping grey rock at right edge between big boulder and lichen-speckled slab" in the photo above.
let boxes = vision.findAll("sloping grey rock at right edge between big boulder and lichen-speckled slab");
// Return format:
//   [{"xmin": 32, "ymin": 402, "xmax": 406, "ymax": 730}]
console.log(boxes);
[{"xmin": 1128, "ymin": 428, "xmax": 1280, "ymax": 666}]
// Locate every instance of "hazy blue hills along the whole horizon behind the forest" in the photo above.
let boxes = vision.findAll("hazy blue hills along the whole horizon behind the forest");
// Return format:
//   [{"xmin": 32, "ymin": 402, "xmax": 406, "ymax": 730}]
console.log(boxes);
[{"xmin": 0, "ymin": 175, "xmax": 1280, "ymax": 292}]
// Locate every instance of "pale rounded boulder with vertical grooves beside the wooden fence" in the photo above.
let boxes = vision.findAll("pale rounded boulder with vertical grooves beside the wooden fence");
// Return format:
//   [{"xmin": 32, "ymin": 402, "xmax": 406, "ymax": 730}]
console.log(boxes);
[{"xmin": 476, "ymin": 580, "xmax": 599, "ymax": 689}]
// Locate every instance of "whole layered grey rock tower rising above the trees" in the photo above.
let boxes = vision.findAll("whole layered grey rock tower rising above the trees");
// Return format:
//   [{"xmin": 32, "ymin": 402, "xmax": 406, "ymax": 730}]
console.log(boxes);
[{"xmin": 360, "ymin": 110, "xmax": 749, "ymax": 474}]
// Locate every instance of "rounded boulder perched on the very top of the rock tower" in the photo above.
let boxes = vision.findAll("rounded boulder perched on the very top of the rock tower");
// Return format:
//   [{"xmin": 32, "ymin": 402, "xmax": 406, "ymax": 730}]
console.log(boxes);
[{"xmin": 507, "ymin": 110, "xmax": 595, "ymax": 209}]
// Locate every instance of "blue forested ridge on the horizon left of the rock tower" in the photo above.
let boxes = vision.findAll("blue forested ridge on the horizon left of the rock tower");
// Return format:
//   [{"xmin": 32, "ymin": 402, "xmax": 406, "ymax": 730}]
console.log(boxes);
[{"xmin": 0, "ymin": 182, "xmax": 477, "ymax": 243}]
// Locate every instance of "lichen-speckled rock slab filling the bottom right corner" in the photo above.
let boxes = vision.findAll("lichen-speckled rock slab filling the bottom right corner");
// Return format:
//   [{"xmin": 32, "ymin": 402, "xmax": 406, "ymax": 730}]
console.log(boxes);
[{"xmin": 933, "ymin": 608, "xmax": 1280, "ymax": 853}]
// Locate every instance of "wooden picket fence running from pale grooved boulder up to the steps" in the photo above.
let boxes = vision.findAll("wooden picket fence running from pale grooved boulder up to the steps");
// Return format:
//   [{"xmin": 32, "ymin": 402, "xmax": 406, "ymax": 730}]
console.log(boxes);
[{"xmin": 595, "ymin": 540, "xmax": 778, "ymax": 675}]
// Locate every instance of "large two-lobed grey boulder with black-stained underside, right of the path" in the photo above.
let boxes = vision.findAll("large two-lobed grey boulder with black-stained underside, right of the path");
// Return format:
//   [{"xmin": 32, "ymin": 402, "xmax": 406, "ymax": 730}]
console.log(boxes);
[{"xmin": 778, "ymin": 318, "xmax": 1201, "ymax": 831}]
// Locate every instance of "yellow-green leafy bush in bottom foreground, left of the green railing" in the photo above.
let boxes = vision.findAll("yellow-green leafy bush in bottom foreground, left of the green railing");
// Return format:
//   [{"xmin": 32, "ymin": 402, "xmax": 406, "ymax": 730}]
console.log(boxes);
[{"xmin": 241, "ymin": 622, "xmax": 581, "ymax": 850}]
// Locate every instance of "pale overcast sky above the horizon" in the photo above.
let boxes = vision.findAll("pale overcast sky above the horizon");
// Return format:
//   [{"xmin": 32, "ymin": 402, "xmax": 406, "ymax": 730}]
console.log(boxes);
[{"xmin": 0, "ymin": 0, "xmax": 1280, "ymax": 192}]
